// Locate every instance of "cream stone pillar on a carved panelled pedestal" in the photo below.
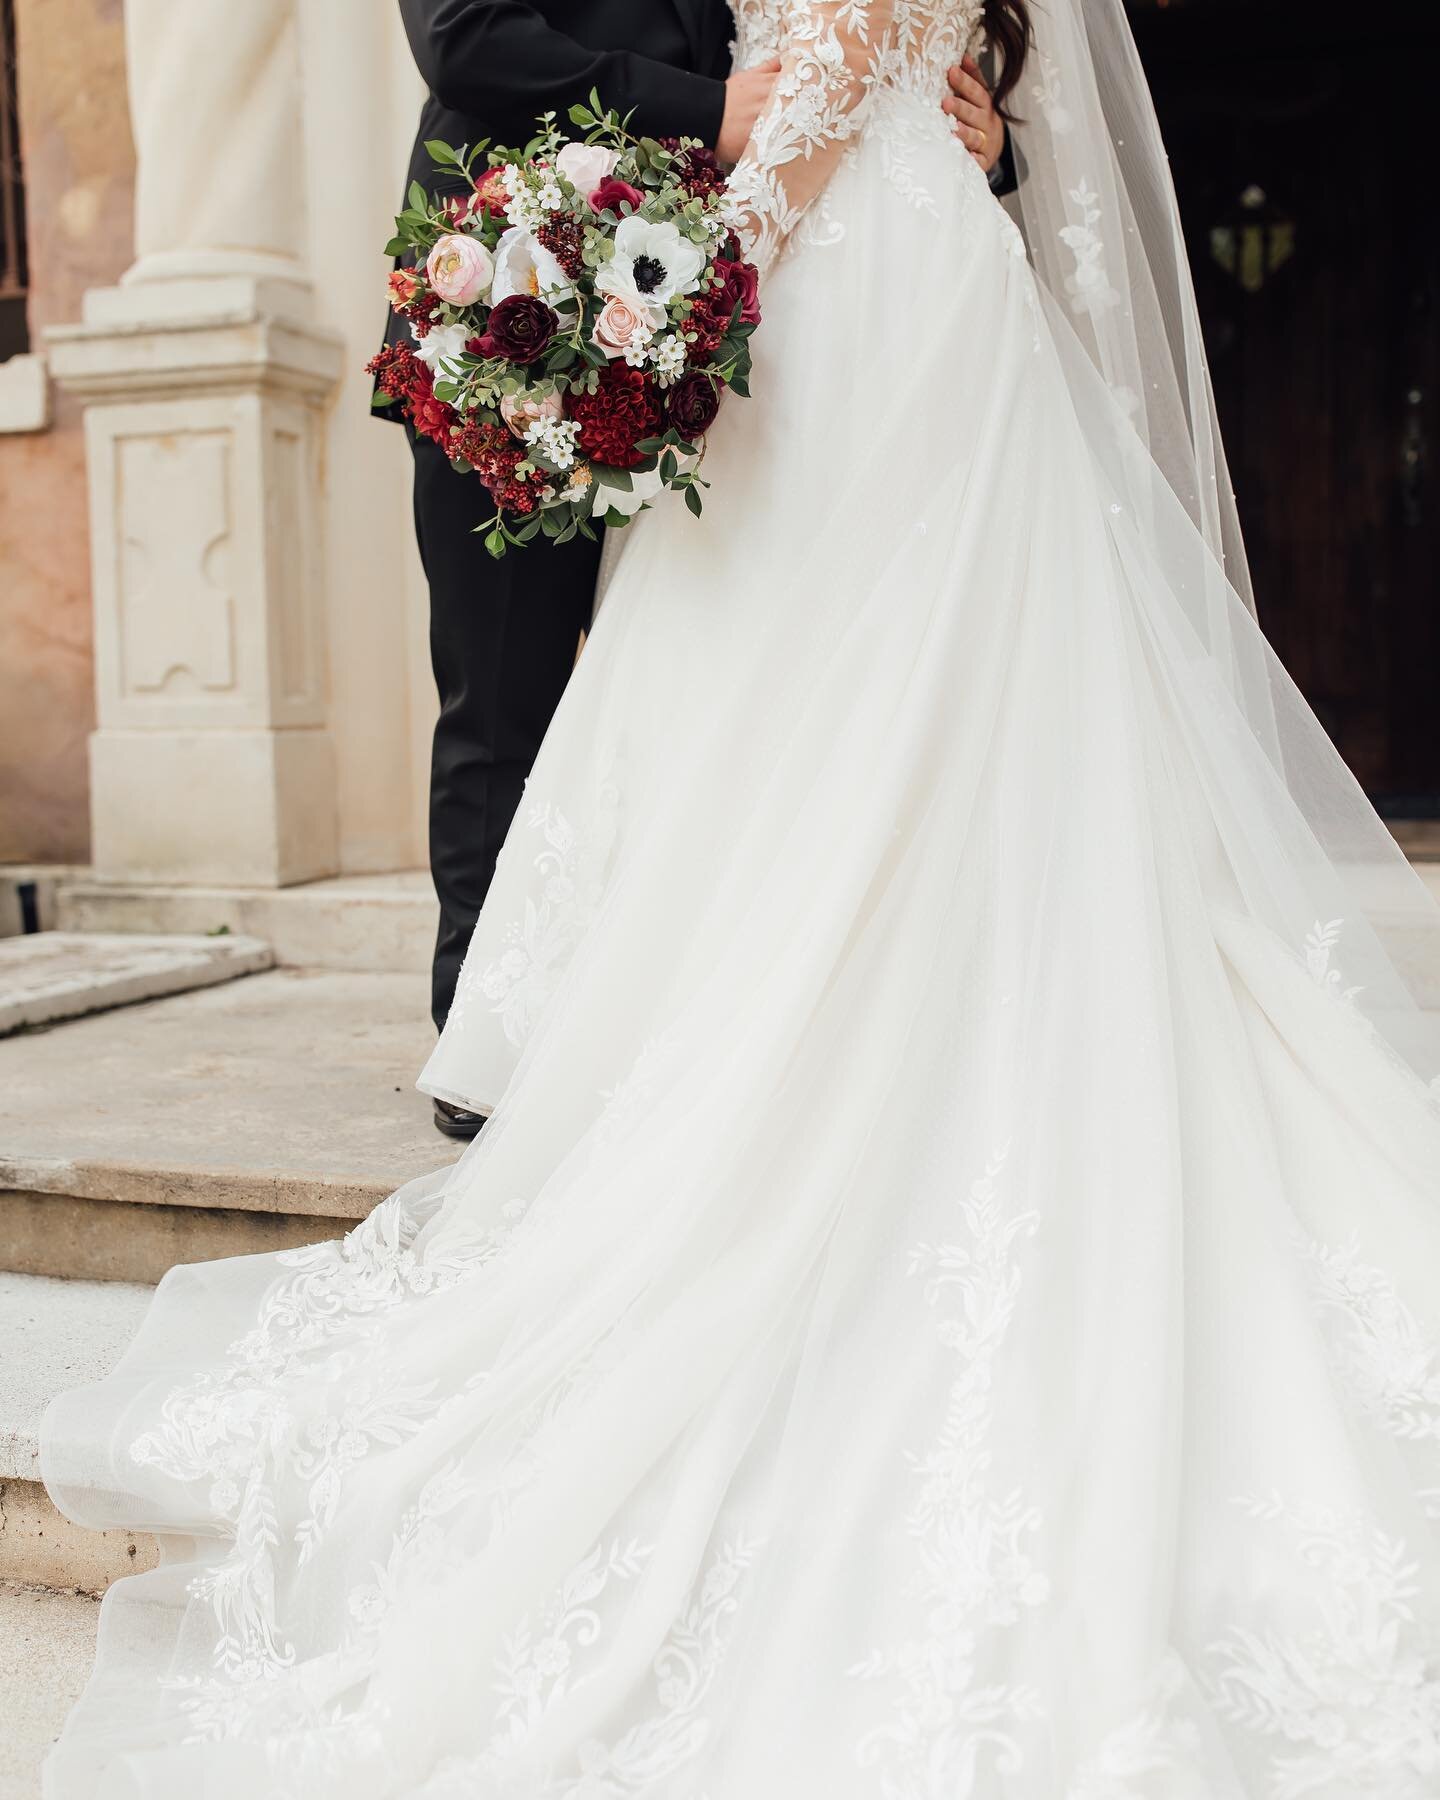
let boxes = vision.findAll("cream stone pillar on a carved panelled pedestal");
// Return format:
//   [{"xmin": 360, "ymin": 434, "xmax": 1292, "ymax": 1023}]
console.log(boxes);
[{"xmin": 47, "ymin": 0, "xmax": 344, "ymax": 886}]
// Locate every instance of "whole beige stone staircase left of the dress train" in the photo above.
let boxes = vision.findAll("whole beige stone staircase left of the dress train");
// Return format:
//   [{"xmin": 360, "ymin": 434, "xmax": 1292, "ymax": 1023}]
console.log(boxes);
[{"xmin": 0, "ymin": 875, "xmax": 455, "ymax": 1800}]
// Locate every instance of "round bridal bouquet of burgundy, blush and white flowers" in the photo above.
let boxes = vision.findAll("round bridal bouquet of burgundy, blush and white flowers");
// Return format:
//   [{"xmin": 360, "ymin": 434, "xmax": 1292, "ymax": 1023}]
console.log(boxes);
[{"xmin": 369, "ymin": 94, "xmax": 760, "ymax": 556}]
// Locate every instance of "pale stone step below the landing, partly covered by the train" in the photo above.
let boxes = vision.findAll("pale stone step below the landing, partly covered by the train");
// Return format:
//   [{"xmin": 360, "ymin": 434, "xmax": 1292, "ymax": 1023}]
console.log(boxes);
[{"xmin": 0, "ymin": 1274, "xmax": 158, "ymax": 1593}]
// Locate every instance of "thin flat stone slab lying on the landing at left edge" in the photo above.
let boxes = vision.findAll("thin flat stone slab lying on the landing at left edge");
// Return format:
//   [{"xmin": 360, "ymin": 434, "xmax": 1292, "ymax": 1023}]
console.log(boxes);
[{"xmin": 0, "ymin": 931, "xmax": 275, "ymax": 1037}]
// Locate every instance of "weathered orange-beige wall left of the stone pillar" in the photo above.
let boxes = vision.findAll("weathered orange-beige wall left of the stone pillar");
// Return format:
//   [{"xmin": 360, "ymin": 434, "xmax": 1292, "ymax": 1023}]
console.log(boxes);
[{"xmin": 0, "ymin": 0, "xmax": 133, "ymax": 862}]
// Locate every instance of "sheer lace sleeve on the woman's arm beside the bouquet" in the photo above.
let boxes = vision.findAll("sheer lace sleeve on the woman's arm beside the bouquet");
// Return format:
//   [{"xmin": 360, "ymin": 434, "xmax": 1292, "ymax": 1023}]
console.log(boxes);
[{"xmin": 731, "ymin": 0, "xmax": 893, "ymax": 268}]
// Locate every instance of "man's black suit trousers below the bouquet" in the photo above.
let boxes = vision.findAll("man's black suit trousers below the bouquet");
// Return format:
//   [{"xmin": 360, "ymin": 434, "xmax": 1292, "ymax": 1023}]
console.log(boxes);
[{"xmin": 410, "ymin": 432, "xmax": 599, "ymax": 1030}]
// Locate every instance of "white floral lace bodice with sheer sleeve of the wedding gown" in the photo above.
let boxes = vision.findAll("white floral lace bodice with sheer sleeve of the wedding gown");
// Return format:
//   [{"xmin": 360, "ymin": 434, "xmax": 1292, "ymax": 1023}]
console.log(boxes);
[{"xmin": 731, "ymin": 0, "xmax": 983, "ymax": 266}]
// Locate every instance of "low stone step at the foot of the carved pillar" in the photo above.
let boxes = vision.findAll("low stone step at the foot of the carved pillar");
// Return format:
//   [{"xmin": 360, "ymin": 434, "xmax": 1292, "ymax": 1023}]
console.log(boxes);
[{"xmin": 54, "ymin": 869, "xmax": 437, "ymax": 974}]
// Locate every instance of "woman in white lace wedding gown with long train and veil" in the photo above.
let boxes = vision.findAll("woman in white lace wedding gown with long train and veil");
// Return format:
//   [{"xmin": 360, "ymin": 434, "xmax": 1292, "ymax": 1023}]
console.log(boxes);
[{"xmin": 45, "ymin": 0, "xmax": 1440, "ymax": 1800}]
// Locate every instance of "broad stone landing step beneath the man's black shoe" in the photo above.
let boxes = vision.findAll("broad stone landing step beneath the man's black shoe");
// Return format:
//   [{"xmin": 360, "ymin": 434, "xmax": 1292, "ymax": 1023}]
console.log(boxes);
[{"xmin": 0, "ymin": 968, "xmax": 457, "ymax": 1282}]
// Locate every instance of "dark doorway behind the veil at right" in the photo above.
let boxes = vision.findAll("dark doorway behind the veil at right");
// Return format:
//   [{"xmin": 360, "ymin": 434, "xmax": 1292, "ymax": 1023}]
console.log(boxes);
[{"xmin": 1130, "ymin": 0, "xmax": 1440, "ymax": 817}]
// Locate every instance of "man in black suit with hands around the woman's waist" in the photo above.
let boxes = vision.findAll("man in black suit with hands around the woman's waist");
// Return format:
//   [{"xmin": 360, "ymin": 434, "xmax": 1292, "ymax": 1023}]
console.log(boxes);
[{"xmin": 387, "ymin": 0, "xmax": 1004, "ymax": 1138}]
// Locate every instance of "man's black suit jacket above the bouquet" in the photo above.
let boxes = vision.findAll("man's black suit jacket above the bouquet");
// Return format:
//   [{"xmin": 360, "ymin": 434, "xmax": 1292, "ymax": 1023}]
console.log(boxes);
[{"xmin": 380, "ymin": 0, "xmax": 733, "ymax": 367}]
